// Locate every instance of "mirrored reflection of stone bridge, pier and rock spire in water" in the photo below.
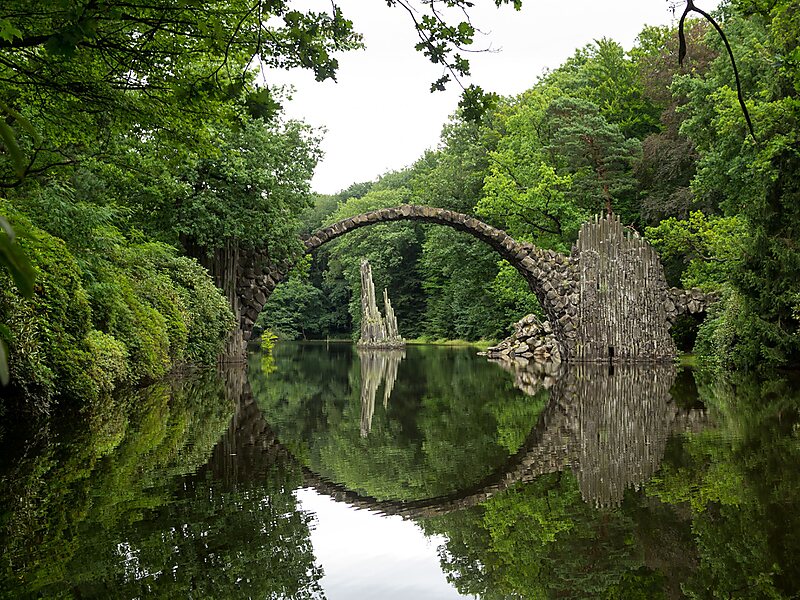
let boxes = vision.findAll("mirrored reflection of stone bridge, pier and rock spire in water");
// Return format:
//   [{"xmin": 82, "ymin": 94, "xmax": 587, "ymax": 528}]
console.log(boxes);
[{"xmin": 215, "ymin": 356, "xmax": 706, "ymax": 518}]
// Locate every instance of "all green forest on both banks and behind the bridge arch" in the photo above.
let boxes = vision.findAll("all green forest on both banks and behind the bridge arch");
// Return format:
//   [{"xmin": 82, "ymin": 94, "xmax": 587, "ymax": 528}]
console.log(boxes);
[{"xmin": 0, "ymin": 0, "xmax": 800, "ymax": 413}]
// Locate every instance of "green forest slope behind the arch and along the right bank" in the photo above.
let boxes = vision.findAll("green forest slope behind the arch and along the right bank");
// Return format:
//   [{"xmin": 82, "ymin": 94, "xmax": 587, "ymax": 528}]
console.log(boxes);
[{"xmin": 262, "ymin": 0, "xmax": 800, "ymax": 369}]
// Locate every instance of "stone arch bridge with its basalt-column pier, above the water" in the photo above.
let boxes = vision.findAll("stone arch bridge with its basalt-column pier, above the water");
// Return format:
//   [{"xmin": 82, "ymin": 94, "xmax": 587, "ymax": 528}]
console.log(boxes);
[{"xmin": 229, "ymin": 209, "xmax": 713, "ymax": 362}]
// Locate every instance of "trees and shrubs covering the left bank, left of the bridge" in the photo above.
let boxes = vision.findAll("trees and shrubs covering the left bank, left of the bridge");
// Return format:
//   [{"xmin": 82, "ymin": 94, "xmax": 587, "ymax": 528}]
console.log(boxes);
[{"xmin": 0, "ymin": 0, "xmax": 360, "ymax": 412}]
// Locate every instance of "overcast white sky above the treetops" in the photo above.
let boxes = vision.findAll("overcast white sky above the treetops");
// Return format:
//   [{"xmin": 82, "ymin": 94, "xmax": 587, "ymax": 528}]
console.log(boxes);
[{"xmin": 266, "ymin": 0, "xmax": 719, "ymax": 193}]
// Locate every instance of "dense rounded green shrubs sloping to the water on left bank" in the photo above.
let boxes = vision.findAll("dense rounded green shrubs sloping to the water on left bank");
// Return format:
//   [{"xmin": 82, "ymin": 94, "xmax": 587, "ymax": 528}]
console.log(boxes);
[{"xmin": 0, "ymin": 202, "xmax": 233, "ymax": 411}]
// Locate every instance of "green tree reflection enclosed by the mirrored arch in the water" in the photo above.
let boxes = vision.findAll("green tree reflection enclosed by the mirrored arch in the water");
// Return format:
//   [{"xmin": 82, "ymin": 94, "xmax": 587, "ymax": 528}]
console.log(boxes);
[{"xmin": 250, "ymin": 344, "xmax": 544, "ymax": 500}]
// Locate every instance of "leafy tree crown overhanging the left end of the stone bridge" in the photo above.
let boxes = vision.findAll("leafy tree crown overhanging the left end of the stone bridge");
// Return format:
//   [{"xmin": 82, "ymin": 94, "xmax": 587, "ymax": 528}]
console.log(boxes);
[{"xmin": 142, "ymin": 120, "xmax": 320, "ymax": 261}]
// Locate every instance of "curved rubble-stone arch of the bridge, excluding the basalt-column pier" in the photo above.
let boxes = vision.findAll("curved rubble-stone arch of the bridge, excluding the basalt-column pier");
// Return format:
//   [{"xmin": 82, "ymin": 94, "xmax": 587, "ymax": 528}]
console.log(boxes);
[{"xmin": 238, "ymin": 204, "xmax": 576, "ymax": 352}]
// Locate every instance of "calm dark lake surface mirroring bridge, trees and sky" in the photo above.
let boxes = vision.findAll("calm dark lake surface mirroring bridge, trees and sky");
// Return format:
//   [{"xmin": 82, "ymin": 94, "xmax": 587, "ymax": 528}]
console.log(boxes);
[{"xmin": 0, "ymin": 344, "xmax": 800, "ymax": 600}]
